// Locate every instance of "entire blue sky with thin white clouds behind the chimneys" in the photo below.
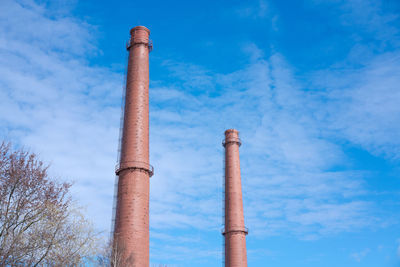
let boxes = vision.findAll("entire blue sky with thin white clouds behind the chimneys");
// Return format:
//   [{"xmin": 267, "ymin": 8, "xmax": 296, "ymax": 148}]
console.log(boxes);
[{"xmin": 0, "ymin": 0, "xmax": 400, "ymax": 267}]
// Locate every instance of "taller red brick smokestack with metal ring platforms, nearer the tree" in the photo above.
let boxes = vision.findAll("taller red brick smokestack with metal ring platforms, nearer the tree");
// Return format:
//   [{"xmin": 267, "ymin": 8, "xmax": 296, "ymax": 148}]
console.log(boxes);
[{"xmin": 113, "ymin": 26, "xmax": 153, "ymax": 267}]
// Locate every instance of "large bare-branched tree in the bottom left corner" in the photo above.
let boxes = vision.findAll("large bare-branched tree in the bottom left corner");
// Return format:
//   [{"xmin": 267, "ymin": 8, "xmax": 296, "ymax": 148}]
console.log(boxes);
[{"xmin": 0, "ymin": 142, "xmax": 97, "ymax": 266}]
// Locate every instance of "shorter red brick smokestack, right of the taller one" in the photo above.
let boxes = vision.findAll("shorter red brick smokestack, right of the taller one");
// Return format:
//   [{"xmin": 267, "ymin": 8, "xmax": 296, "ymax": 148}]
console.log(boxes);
[{"xmin": 222, "ymin": 129, "xmax": 248, "ymax": 267}]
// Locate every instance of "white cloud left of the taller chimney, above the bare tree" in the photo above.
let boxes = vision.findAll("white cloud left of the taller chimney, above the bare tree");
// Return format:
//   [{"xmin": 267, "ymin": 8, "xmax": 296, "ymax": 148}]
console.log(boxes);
[{"xmin": 0, "ymin": 1, "xmax": 122, "ymax": 230}]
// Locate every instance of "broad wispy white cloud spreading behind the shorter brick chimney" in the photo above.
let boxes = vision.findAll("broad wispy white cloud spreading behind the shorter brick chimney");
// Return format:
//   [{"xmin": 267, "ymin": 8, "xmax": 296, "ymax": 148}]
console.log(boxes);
[{"xmin": 151, "ymin": 48, "xmax": 375, "ymax": 245}]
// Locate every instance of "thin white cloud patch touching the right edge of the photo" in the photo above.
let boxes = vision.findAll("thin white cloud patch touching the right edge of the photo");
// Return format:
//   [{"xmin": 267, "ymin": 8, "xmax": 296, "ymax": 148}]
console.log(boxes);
[{"xmin": 314, "ymin": 52, "xmax": 400, "ymax": 160}]
